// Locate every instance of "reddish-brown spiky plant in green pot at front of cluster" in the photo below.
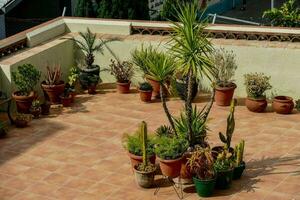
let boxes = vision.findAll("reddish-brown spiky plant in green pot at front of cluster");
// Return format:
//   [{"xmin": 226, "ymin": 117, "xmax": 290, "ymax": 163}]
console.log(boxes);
[{"xmin": 186, "ymin": 147, "xmax": 217, "ymax": 197}]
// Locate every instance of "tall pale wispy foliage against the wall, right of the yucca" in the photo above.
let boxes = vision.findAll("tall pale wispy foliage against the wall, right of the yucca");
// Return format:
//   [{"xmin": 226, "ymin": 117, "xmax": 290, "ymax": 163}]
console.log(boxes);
[{"xmin": 212, "ymin": 48, "xmax": 237, "ymax": 87}]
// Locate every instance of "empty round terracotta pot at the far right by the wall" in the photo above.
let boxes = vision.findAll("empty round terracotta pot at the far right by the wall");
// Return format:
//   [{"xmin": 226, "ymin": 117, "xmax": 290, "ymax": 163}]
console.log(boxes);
[{"xmin": 272, "ymin": 96, "xmax": 294, "ymax": 114}]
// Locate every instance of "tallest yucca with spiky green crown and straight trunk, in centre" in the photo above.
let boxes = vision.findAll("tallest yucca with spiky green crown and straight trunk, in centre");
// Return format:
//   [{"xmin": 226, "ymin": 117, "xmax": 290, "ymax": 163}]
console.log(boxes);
[{"xmin": 170, "ymin": 1, "xmax": 214, "ymax": 146}]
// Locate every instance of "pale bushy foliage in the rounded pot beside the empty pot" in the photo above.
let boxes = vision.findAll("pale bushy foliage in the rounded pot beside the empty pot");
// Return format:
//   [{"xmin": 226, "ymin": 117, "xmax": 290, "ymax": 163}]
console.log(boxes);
[{"xmin": 244, "ymin": 73, "xmax": 272, "ymax": 99}]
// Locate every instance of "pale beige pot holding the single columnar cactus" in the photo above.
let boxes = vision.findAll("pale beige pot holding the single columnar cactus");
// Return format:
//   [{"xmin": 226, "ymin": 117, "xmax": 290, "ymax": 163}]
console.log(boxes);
[{"xmin": 133, "ymin": 166, "xmax": 156, "ymax": 188}]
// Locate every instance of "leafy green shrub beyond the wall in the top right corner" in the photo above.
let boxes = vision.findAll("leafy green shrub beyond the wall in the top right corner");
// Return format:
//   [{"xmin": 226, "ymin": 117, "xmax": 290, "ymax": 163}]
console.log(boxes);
[{"xmin": 263, "ymin": 0, "xmax": 300, "ymax": 27}]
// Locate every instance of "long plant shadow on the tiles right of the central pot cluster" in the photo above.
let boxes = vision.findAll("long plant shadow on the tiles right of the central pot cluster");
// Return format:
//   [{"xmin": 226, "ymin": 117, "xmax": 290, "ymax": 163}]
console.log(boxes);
[{"xmin": 184, "ymin": 154, "xmax": 300, "ymax": 197}]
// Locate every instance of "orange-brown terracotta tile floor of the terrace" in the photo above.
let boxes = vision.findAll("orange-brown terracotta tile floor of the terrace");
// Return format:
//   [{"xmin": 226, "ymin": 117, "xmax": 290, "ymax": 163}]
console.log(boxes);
[{"xmin": 0, "ymin": 92, "xmax": 300, "ymax": 200}]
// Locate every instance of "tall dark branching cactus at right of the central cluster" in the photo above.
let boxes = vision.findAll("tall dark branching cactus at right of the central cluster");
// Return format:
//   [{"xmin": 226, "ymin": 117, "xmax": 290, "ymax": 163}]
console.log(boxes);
[{"xmin": 219, "ymin": 99, "xmax": 235, "ymax": 148}]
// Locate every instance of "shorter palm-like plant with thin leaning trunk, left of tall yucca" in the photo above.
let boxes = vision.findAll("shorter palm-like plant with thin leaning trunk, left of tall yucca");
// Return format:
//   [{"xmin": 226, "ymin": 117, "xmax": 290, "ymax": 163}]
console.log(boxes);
[{"xmin": 146, "ymin": 52, "xmax": 176, "ymax": 134}]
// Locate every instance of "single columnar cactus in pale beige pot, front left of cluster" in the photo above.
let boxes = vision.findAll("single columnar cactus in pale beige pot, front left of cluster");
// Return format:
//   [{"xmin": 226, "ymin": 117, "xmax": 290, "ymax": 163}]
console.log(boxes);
[{"xmin": 134, "ymin": 121, "xmax": 156, "ymax": 188}]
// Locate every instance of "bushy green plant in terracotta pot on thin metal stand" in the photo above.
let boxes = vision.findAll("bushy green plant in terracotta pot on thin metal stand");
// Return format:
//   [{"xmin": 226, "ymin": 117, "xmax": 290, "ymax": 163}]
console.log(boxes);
[{"xmin": 154, "ymin": 136, "xmax": 188, "ymax": 178}]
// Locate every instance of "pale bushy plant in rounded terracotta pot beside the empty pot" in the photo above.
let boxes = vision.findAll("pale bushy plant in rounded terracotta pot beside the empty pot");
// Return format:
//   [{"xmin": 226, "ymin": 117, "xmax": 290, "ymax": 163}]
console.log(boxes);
[{"xmin": 244, "ymin": 73, "xmax": 272, "ymax": 112}]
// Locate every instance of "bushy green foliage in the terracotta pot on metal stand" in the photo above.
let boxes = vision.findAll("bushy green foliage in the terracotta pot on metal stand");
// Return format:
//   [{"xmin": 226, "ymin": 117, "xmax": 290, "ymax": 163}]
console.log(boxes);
[{"xmin": 154, "ymin": 136, "xmax": 188, "ymax": 160}]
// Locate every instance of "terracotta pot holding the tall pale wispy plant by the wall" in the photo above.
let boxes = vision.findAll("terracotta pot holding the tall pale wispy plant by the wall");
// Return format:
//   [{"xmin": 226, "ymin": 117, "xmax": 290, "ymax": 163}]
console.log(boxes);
[{"xmin": 215, "ymin": 83, "xmax": 236, "ymax": 106}]
